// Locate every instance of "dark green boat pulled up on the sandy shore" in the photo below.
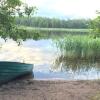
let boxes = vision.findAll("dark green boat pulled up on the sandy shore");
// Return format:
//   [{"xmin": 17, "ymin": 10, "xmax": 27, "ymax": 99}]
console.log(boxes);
[{"xmin": 0, "ymin": 61, "xmax": 33, "ymax": 84}]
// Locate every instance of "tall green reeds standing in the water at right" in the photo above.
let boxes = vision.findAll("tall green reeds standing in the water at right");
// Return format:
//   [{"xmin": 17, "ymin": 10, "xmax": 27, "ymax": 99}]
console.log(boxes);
[{"xmin": 56, "ymin": 35, "xmax": 100, "ymax": 59}]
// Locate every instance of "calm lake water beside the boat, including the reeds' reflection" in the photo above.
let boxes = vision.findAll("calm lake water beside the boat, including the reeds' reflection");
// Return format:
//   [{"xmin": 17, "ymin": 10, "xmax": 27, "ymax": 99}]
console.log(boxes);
[{"xmin": 0, "ymin": 38, "xmax": 100, "ymax": 80}]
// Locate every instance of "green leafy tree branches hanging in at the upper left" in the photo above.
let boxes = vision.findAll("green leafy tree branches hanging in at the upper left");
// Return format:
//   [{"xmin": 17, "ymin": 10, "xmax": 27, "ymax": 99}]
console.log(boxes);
[{"xmin": 0, "ymin": 0, "xmax": 35, "ymax": 40}]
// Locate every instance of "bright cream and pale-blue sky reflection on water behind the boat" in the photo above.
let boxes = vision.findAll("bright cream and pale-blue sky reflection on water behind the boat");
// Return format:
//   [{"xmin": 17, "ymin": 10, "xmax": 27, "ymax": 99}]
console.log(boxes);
[{"xmin": 0, "ymin": 39, "xmax": 55, "ymax": 64}]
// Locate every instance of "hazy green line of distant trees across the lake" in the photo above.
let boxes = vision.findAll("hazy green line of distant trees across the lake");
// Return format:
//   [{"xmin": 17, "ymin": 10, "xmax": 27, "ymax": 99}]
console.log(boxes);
[{"xmin": 15, "ymin": 17, "xmax": 91, "ymax": 29}]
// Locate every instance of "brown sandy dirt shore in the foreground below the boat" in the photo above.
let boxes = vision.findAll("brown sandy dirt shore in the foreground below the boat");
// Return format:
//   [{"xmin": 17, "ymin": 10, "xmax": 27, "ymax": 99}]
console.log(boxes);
[{"xmin": 0, "ymin": 79, "xmax": 100, "ymax": 100}]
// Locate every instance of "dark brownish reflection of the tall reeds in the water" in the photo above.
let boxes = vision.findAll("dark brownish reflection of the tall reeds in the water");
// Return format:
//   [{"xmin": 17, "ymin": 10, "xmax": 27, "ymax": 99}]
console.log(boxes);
[{"xmin": 53, "ymin": 56, "xmax": 100, "ymax": 72}]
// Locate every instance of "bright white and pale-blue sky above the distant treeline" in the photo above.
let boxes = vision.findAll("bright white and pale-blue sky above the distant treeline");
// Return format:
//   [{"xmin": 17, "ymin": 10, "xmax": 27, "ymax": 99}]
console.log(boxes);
[{"xmin": 24, "ymin": 0, "xmax": 100, "ymax": 19}]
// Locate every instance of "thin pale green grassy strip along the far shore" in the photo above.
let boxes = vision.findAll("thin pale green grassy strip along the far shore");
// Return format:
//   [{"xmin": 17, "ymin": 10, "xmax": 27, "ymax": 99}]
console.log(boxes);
[{"xmin": 19, "ymin": 26, "xmax": 91, "ymax": 34}]
